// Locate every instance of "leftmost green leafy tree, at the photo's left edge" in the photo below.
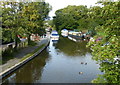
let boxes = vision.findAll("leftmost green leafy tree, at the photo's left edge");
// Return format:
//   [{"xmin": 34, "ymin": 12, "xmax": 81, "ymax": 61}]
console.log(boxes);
[{"xmin": 1, "ymin": 2, "xmax": 23, "ymax": 47}]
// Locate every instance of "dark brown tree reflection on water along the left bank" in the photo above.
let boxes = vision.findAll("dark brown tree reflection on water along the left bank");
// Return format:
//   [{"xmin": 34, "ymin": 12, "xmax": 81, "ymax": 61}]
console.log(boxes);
[{"xmin": 3, "ymin": 49, "xmax": 49, "ymax": 83}]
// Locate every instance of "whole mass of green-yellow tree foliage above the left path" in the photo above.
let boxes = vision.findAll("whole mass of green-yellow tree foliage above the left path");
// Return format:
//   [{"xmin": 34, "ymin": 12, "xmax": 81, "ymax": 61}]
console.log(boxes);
[{"xmin": 0, "ymin": 1, "xmax": 51, "ymax": 47}]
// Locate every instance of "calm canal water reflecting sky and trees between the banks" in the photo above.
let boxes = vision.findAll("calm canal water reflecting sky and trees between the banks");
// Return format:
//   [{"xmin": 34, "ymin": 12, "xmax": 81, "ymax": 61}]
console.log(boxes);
[{"xmin": 3, "ymin": 37, "xmax": 101, "ymax": 83}]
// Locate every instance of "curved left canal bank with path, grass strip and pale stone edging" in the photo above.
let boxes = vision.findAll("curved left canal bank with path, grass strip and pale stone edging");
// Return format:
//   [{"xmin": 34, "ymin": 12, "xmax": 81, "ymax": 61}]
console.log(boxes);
[{"xmin": 0, "ymin": 38, "xmax": 49, "ymax": 79}]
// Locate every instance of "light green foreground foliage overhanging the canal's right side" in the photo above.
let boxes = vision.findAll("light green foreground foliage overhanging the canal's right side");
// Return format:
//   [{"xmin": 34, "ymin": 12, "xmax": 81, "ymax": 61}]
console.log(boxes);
[{"xmin": 88, "ymin": 2, "xmax": 120, "ymax": 83}]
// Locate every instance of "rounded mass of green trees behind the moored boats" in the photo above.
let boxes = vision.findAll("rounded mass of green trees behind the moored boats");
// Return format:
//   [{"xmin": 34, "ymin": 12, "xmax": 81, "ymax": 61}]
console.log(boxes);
[{"xmin": 53, "ymin": 5, "xmax": 103, "ymax": 30}]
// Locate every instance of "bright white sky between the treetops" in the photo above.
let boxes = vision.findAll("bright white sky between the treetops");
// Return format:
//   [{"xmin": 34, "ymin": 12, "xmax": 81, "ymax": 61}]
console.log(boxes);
[{"xmin": 45, "ymin": 0, "xmax": 101, "ymax": 17}]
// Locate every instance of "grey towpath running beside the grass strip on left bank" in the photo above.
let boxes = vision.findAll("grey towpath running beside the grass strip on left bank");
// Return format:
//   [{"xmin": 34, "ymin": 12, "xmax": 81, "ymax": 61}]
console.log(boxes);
[{"xmin": 0, "ymin": 38, "xmax": 48, "ymax": 72}]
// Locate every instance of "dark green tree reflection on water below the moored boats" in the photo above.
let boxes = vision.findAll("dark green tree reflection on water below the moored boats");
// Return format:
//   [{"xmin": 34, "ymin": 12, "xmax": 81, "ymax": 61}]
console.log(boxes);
[{"xmin": 55, "ymin": 37, "xmax": 91, "ymax": 57}]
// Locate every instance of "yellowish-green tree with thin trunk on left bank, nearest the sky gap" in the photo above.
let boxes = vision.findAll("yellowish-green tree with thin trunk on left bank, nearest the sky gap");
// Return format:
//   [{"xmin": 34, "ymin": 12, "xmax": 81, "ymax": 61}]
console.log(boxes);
[{"xmin": 22, "ymin": 2, "xmax": 51, "ymax": 44}]
